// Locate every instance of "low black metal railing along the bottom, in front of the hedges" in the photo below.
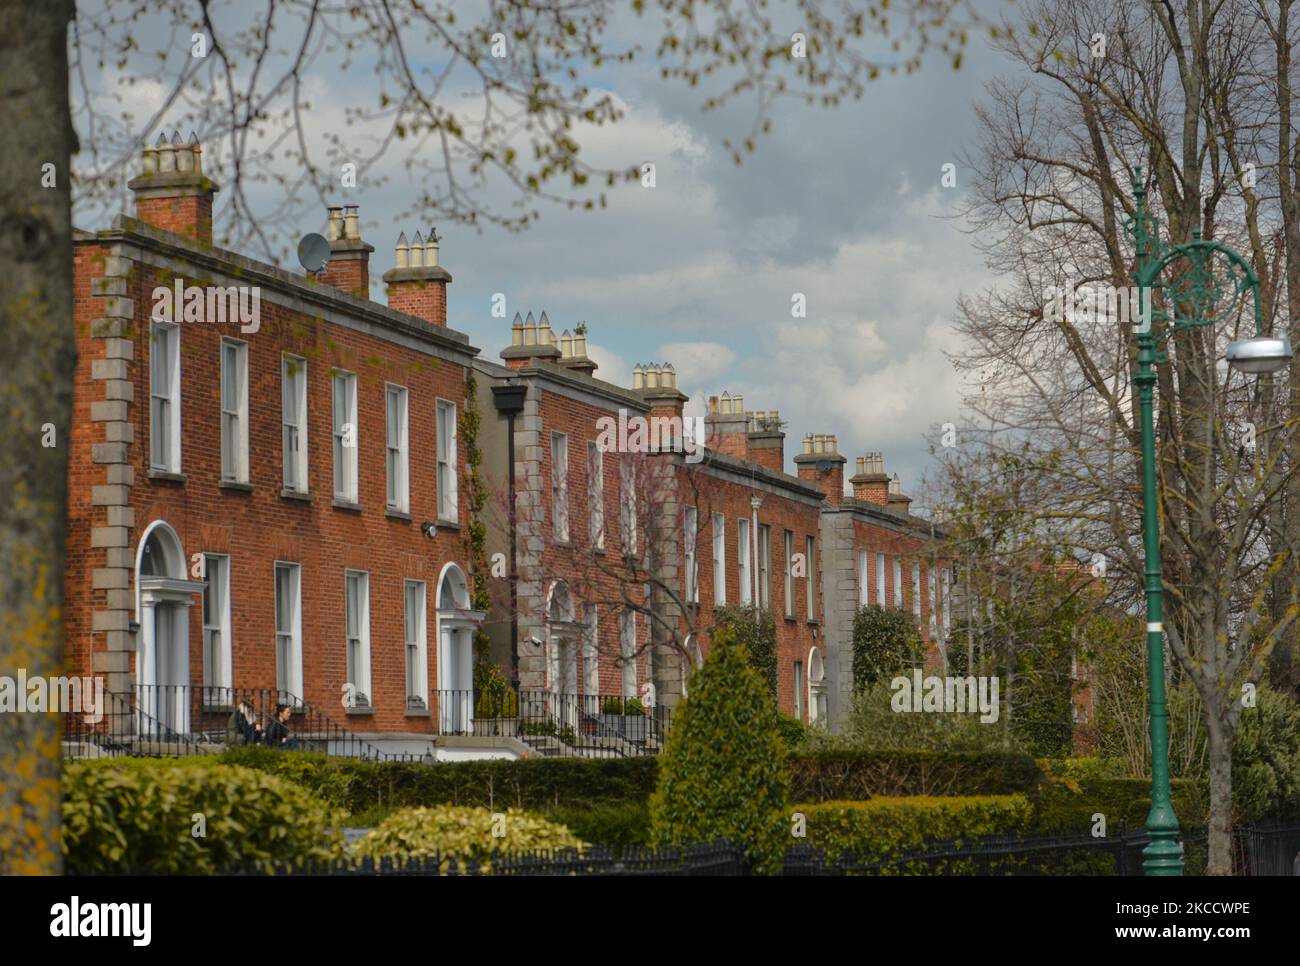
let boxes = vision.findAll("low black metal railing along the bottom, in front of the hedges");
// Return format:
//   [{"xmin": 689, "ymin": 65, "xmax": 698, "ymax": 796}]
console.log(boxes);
[{"xmin": 94, "ymin": 822, "xmax": 1300, "ymax": 876}]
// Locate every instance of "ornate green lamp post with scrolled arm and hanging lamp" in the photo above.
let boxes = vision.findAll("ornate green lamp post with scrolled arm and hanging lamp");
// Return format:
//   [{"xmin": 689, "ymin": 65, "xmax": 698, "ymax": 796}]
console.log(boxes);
[{"xmin": 1126, "ymin": 169, "xmax": 1291, "ymax": 875}]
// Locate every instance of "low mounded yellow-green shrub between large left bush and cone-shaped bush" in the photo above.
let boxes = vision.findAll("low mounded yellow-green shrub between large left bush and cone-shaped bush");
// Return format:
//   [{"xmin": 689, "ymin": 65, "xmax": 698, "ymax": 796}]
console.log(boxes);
[{"xmin": 352, "ymin": 805, "xmax": 584, "ymax": 871}]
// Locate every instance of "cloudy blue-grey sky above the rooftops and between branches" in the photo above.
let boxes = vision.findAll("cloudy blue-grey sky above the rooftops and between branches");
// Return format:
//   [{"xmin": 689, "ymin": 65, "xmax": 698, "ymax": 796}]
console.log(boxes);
[{"xmin": 74, "ymin": 3, "xmax": 1010, "ymax": 507}]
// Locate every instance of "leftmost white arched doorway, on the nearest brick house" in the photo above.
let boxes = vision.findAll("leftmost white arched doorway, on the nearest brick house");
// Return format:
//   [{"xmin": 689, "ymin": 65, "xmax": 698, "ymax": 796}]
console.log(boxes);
[{"xmin": 135, "ymin": 520, "xmax": 203, "ymax": 735}]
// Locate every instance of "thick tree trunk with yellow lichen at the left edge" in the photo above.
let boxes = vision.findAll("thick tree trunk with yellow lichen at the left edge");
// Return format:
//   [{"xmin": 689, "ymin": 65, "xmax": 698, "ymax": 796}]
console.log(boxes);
[{"xmin": 0, "ymin": 0, "xmax": 75, "ymax": 875}]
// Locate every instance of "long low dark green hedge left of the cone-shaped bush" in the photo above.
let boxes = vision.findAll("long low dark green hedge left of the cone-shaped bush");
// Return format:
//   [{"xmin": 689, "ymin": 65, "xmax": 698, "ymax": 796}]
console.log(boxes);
[{"xmin": 220, "ymin": 748, "xmax": 658, "ymax": 815}]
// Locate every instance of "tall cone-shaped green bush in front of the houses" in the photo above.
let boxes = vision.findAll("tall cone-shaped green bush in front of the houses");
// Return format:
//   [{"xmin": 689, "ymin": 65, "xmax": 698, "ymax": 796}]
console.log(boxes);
[{"xmin": 650, "ymin": 627, "xmax": 788, "ymax": 874}]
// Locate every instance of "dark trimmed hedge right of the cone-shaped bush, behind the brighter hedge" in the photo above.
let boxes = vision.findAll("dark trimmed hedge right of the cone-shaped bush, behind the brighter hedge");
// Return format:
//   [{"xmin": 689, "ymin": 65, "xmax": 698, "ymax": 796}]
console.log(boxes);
[{"xmin": 789, "ymin": 750, "xmax": 1043, "ymax": 802}]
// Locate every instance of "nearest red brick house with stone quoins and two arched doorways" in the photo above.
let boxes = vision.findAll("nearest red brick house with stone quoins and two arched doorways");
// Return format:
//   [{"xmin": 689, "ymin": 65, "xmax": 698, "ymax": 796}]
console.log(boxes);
[{"xmin": 65, "ymin": 135, "xmax": 482, "ymax": 750}]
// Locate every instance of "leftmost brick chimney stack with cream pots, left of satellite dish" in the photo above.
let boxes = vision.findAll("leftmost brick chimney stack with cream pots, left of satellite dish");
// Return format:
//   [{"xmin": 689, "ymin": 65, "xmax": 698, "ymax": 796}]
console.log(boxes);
[{"xmin": 127, "ymin": 131, "xmax": 218, "ymax": 246}]
